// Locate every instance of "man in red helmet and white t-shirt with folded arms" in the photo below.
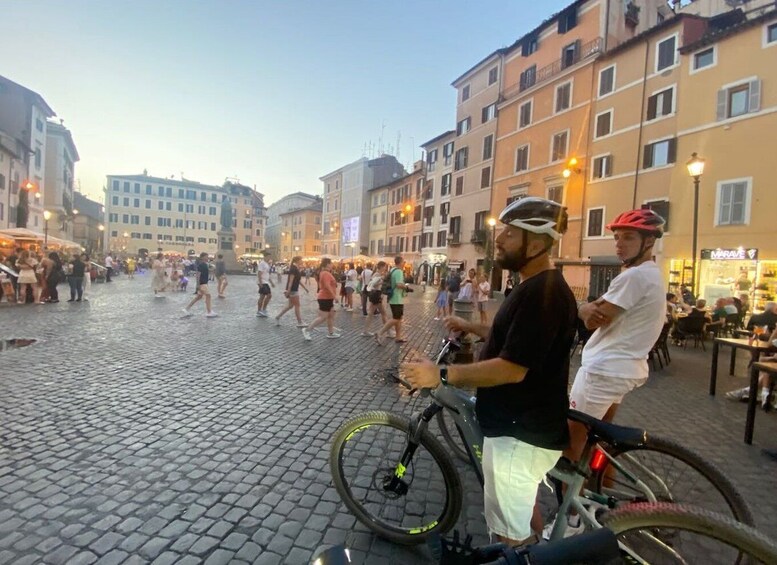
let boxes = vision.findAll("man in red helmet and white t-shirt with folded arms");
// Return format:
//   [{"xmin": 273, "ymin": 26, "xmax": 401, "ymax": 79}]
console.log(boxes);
[{"xmin": 543, "ymin": 209, "xmax": 666, "ymax": 538}]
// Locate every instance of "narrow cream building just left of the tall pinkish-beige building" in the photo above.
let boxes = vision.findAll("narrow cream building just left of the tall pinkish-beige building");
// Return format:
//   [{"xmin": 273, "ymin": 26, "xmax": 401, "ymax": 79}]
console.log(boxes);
[{"xmin": 421, "ymin": 130, "xmax": 454, "ymax": 282}]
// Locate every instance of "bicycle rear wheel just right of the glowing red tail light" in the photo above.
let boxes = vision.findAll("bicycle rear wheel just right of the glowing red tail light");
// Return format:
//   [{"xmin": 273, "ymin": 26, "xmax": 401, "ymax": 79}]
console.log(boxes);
[{"xmin": 596, "ymin": 436, "xmax": 755, "ymax": 526}]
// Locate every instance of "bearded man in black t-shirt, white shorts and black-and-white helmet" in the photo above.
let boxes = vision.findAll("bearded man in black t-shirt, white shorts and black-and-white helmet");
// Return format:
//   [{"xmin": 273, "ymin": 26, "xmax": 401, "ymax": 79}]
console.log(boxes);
[{"xmin": 404, "ymin": 197, "xmax": 577, "ymax": 545}]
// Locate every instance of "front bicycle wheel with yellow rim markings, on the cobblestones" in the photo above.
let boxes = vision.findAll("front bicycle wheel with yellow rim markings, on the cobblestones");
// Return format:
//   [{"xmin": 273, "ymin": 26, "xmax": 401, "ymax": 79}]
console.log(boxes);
[{"xmin": 329, "ymin": 412, "xmax": 462, "ymax": 545}]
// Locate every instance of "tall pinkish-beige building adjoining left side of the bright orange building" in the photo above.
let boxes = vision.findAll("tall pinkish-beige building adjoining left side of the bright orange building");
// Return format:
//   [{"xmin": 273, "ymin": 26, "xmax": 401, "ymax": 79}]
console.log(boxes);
[{"xmin": 448, "ymin": 49, "xmax": 504, "ymax": 269}]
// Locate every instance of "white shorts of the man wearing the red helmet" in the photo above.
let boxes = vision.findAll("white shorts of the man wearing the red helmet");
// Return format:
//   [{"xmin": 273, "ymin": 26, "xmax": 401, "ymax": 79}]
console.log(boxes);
[{"xmin": 569, "ymin": 367, "xmax": 647, "ymax": 420}]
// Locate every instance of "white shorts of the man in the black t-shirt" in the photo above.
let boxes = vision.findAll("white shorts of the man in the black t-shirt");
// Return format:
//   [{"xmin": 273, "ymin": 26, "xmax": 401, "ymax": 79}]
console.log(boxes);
[{"xmin": 483, "ymin": 436, "xmax": 561, "ymax": 541}]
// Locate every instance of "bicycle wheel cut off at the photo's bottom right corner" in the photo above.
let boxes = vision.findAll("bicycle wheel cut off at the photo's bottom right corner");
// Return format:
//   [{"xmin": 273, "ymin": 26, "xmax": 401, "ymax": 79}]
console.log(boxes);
[{"xmin": 602, "ymin": 503, "xmax": 777, "ymax": 565}]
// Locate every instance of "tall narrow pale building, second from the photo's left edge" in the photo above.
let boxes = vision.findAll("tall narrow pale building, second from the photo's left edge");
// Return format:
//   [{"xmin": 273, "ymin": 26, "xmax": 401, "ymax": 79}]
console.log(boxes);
[{"xmin": 42, "ymin": 122, "xmax": 80, "ymax": 240}]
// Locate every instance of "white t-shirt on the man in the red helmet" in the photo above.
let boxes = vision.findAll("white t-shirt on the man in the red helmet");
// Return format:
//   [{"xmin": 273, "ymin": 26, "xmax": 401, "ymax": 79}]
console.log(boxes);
[{"xmin": 582, "ymin": 261, "xmax": 666, "ymax": 379}]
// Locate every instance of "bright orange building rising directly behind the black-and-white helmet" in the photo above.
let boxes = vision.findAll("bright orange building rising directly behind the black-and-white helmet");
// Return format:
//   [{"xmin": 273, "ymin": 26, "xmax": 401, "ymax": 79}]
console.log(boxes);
[{"xmin": 492, "ymin": 0, "xmax": 660, "ymax": 286}]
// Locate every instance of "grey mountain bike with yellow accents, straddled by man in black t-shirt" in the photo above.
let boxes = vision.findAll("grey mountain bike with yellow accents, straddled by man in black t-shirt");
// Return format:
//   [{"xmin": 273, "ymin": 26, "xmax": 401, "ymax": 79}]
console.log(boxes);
[{"xmin": 329, "ymin": 342, "xmax": 752, "ymax": 545}]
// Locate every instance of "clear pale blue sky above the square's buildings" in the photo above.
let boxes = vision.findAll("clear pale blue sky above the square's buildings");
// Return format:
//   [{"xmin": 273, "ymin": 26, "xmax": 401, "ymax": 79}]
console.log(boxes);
[{"xmin": 0, "ymin": 0, "xmax": 571, "ymax": 204}]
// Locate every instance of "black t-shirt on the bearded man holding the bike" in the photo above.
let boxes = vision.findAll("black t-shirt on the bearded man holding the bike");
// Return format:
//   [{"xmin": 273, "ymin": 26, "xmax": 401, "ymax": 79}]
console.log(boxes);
[{"xmin": 476, "ymin": 269, "xmax": 577, "ymax": 449}]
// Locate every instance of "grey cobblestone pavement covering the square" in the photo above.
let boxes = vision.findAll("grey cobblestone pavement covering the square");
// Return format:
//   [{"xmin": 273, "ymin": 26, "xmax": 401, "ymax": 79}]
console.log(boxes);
[{"xmin": 0, "ymin": 270, "xmax": 777, "ymax": 564}]
